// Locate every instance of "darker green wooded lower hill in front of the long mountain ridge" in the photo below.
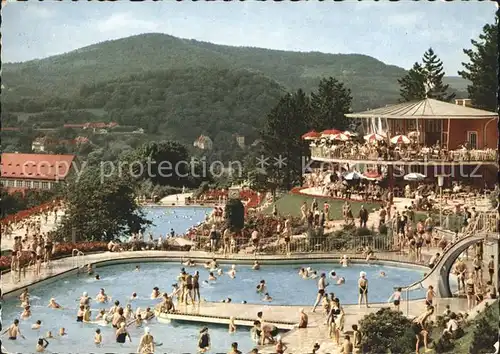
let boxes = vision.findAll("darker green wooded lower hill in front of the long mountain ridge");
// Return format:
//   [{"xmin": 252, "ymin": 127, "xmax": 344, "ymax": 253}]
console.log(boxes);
[{"xmin": 2, "ymin": 68, "xmax": 284, "ymax": 148}]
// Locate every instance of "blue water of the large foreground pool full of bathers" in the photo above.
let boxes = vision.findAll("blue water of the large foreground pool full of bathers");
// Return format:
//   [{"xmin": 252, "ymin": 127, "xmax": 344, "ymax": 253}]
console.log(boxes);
[{"xmin": 3, "ymin": 263, "xmax": 423, "ymax": 354}]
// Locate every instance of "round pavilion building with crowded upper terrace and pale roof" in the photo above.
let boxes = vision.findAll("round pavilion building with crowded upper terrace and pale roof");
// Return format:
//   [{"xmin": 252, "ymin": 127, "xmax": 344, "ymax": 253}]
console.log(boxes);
[{"xmin": 303, "ymin": 98, "xmax": 498, "ymax": 188}]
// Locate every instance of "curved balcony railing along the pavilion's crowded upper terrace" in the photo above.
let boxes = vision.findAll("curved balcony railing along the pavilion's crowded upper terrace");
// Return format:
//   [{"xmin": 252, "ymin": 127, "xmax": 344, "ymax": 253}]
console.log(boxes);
[{"xmin": 310, "ymin": 146, "xmax": 498, "ymax": 162}]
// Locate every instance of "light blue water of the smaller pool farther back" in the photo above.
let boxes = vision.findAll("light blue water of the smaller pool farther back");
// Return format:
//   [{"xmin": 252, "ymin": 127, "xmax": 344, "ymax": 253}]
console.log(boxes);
[{"xmin": 143, "ymin": 206, "xmax": 213, "ymax": 239}]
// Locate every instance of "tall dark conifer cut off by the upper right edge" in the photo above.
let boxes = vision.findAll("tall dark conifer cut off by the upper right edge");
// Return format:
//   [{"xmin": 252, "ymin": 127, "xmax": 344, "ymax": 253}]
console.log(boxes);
[{"xmin": 458, "ymin": 11, "xmax": 499, "ymax": 112}]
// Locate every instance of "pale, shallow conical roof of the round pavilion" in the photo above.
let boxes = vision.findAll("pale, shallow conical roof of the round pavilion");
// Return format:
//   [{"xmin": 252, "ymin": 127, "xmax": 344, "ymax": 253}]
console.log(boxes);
[{"xmin": 346, "ymin": 98, "xmax": 498, "ymax": 119}]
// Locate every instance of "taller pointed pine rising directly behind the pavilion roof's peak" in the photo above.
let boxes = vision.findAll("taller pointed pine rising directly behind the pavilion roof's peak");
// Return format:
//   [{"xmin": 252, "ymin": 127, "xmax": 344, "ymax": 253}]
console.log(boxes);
[{"xmin": 422, "ymin": 48, "xmax": 455, "ymax": 102}]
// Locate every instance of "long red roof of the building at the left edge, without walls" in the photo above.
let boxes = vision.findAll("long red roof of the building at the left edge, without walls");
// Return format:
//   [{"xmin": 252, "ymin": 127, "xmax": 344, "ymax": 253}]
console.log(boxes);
[{"xmin": 0, "ymin": 153, "xmax": 75, "ymax": 181}]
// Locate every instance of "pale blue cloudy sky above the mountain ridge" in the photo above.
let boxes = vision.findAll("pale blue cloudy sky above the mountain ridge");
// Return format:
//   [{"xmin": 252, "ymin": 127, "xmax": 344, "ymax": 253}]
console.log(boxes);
[{"xmin": 2, "ymin": 0, "xmax": 496, "ymax": 76}]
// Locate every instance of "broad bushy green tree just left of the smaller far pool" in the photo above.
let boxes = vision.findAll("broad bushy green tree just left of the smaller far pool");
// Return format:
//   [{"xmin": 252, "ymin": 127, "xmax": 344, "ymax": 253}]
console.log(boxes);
[{"xmin": 56, "ymin": 167, "xmax": 151, "ymax": 241}]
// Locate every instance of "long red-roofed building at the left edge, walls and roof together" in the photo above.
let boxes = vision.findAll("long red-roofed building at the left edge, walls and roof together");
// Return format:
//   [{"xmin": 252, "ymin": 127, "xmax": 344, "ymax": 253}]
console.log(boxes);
[{"xmin": 0, "ymin": 153, "xmax": 76, "ymax": 190}]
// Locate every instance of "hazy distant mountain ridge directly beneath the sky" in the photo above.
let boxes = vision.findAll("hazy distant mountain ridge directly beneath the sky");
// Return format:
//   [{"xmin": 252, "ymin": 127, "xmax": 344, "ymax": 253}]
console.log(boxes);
[{"xmin": 2, "ymin": 34, "xmax": 412, "ymax": 109}]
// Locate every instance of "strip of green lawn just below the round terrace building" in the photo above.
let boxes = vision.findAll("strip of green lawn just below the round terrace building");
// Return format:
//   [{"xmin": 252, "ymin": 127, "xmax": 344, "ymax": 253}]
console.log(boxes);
[{"xmin": 263, "ymin": 193, "xmax": 380, "ymax": 220}]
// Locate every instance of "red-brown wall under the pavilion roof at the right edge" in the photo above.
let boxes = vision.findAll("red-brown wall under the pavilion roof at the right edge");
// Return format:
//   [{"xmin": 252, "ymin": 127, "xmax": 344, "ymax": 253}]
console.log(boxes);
[{"xmin": 448, "ymin": 119, "xmax": 497, "ymax": 149}]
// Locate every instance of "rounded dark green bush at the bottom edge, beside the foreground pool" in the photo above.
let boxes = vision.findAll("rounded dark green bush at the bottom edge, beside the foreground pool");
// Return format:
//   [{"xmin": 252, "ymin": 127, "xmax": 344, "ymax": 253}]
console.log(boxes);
[{"xmin": 359, "ymin": 308, "xmax": 415, "ymax": 354}]
